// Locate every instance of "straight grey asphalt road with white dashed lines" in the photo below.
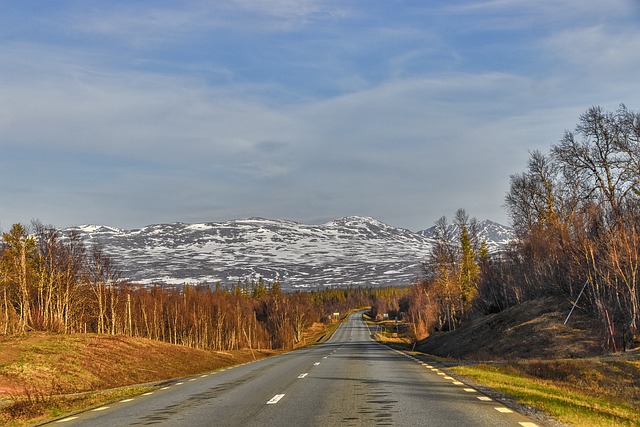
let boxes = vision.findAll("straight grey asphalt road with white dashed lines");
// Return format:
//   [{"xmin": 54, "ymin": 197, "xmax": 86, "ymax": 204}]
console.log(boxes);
[{"xmin": 50, "ymin": 314, "xmax": 536, "ymax": 427}]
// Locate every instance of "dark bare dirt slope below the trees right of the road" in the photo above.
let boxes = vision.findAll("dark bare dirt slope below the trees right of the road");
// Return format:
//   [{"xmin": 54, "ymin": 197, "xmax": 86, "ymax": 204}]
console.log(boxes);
[{"xmin": 416, "ymin": 298, "xmax": 604, "ymax": 360}]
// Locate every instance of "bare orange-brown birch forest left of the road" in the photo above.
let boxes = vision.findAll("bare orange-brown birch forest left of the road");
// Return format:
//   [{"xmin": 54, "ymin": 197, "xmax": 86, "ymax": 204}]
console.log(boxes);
[{"xmin": 0, "ymin": 221, "xmax": 398, "ymax": 350}]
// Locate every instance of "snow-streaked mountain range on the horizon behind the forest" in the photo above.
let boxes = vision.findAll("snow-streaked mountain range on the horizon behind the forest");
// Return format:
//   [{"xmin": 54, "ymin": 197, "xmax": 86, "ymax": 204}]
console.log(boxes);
[{"xmin": 63, "ymin": 217, "xmax": 510, "ymax": 289}]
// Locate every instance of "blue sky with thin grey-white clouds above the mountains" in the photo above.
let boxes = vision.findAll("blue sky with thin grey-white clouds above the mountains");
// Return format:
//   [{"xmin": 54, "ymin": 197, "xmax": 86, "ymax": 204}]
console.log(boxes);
[{"xmin": 0, "ymin": 0, "xmax": 640, "ymax": 231}]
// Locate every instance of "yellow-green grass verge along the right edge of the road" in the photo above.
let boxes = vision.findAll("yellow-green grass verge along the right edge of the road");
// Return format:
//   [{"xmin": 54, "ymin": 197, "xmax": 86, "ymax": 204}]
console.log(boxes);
[{"xmin": 451, "ymin": 359, "xmax": 640, "ymax": 426}]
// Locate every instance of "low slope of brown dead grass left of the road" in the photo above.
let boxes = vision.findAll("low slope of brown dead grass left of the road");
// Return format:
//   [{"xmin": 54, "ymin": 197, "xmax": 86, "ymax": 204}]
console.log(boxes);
[{"xmin": 0, "ymin": 333, "xmax": 274, "ymax": 397}]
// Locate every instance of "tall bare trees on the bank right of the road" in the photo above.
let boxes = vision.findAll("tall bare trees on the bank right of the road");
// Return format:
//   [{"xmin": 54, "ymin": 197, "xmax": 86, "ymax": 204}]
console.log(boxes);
[{"xmin": 398, "ymin": 105, "xmax": 640, "ymax": 348}]
